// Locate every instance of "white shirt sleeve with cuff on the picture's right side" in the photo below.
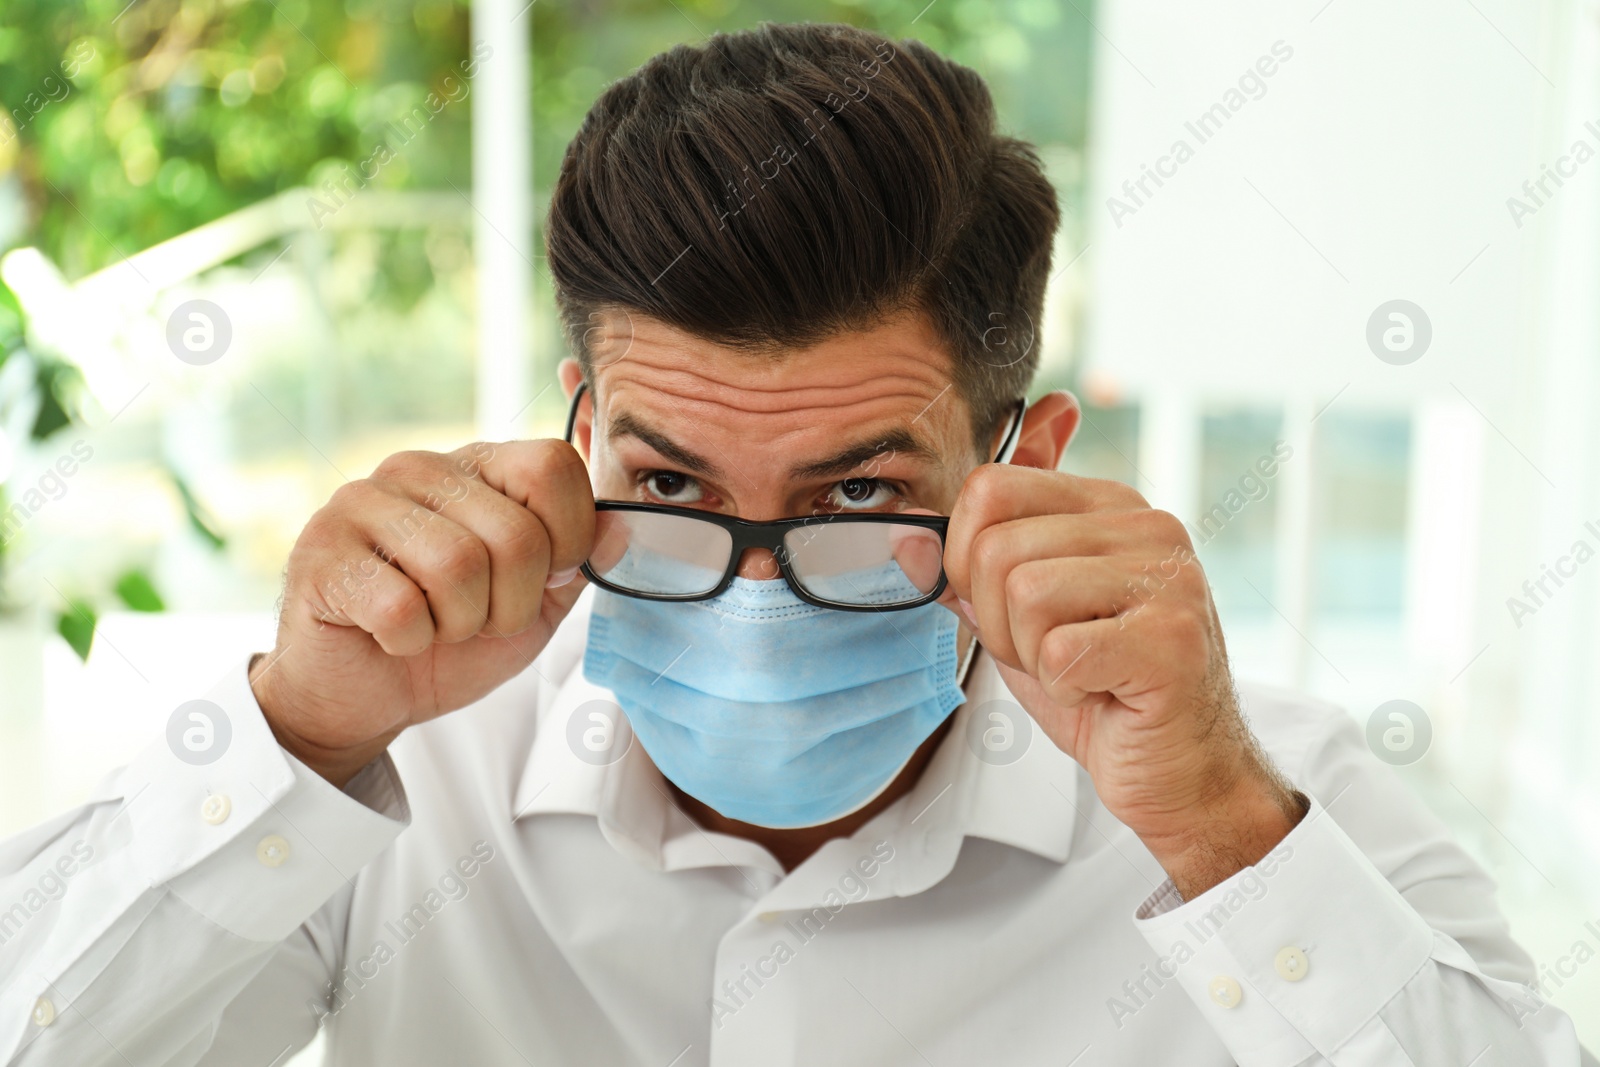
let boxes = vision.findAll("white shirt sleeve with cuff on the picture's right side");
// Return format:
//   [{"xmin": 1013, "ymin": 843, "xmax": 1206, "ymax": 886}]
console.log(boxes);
[{"xmin": 1134, "ymin": 703, "xmax": 1579, "ymax": 1067}]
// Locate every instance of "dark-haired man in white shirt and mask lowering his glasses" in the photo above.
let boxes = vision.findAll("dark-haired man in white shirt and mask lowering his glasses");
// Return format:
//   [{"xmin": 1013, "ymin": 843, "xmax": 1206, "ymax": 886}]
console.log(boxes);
[{"xmin": 0, "ymin": 18, "xmax": 1579, "ymax": 1067}]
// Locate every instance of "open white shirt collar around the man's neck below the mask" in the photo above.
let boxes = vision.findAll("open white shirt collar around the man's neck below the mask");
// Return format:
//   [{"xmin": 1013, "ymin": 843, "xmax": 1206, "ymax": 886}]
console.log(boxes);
[{"xmin": 510, "ymin": 589, "xmax": 1082, "ymax": 896}]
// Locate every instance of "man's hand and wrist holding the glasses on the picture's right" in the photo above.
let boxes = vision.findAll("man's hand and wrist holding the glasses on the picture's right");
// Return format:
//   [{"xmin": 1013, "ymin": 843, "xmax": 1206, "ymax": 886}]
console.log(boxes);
[{"xmin": 944, "ymin": 464, "xmax": 1304, "ymax": 901}]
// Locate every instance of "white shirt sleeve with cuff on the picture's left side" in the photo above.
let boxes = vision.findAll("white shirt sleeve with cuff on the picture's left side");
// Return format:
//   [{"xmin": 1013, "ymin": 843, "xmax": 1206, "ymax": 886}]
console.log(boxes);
[{"xmin": 0, "ymin": 664, "xmax": 410, "ymax": 1067}]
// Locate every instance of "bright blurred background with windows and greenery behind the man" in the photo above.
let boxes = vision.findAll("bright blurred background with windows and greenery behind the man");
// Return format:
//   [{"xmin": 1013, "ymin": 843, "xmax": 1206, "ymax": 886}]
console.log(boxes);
[{"xmin": 0, "ymin": 0, "xmax": 1600, "ymax": 1048}]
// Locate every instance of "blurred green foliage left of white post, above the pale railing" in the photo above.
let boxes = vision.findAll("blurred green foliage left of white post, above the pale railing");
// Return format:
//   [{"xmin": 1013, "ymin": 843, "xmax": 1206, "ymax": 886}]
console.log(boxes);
[{"xmin": 0, "ymin": 0, "xmax": 469, "ymax": 277}]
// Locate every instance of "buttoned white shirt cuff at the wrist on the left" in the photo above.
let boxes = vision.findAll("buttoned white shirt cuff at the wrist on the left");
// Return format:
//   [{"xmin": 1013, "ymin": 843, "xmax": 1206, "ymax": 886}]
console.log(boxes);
[{"xmin": 120, "ymin": 662, "xmax": 411, "ymax": 941}]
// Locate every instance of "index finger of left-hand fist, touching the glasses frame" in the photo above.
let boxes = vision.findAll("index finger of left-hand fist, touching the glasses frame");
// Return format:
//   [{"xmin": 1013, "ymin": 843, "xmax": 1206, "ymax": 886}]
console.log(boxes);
[{"xmin": 472, "ymin": 440, "xmax": 595, "ymax": 576}]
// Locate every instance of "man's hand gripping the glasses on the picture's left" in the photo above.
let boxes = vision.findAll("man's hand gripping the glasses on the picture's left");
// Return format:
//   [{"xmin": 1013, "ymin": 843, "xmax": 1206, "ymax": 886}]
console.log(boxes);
[{"xmin": 250, "ymin": 440, "xmax": 595, "ymax": 787}]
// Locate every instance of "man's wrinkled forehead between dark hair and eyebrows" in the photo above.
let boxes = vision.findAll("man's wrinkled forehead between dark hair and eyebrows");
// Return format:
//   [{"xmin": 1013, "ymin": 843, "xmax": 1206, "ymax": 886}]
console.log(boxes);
[{"xmin": 587, "ymin": 312, "xmax": 968, "ymax": 456}]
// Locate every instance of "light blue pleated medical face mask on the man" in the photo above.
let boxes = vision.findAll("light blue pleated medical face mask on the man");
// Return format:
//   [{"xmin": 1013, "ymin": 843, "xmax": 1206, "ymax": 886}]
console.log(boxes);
[{"xmin": 584, "ymin": 565, "xmax": 971, "ymax": 829}]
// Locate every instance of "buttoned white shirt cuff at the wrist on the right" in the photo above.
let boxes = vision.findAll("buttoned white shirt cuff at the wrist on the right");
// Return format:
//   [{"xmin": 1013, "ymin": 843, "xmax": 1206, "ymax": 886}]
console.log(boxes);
[{"xmin": 1133, "ymin": 800, "xmax": 1434, "ymax": 1067}]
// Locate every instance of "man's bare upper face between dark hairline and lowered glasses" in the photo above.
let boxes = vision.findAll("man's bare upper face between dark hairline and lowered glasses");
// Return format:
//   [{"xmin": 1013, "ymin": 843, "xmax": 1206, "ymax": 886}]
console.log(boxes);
[{"xmin": 566, "ymin": 303, "xmax": 984, "ymax": 579}]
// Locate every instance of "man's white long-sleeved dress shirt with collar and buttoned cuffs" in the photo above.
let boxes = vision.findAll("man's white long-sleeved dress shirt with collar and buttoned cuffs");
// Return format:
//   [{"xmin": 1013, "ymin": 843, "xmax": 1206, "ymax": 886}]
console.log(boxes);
[{"xmin": 0, "ymin": 593, "xmax": 1579, "ymax": 1067}]
